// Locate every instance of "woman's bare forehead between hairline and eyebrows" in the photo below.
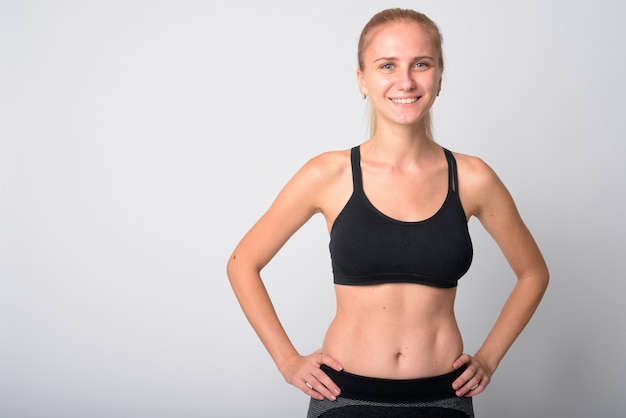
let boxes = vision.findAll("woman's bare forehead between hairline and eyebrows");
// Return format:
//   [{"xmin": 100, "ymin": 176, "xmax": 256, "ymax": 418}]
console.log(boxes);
[{"xmin": 364, "ymin": 21, "xmax": 439, "ymax": 61}]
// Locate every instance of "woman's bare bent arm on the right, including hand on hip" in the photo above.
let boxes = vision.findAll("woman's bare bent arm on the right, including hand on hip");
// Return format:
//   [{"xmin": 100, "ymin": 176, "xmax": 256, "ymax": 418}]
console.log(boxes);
[{"xmin": 454, "ymin": 158, "xmax": 549, "ymax": 396}]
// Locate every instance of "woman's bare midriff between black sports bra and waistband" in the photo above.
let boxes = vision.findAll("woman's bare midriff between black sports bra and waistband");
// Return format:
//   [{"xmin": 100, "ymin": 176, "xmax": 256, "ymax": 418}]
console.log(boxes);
[{"xmin": 322, "ymin": 283, "xmax": 463, "ymax": 379}]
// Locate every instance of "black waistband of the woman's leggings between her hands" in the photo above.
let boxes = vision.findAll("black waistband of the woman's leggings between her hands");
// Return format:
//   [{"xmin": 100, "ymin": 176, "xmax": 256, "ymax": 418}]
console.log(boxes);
[{"xmin": 321, "ymin": 365, "xmax": 465, "ymax": 402}]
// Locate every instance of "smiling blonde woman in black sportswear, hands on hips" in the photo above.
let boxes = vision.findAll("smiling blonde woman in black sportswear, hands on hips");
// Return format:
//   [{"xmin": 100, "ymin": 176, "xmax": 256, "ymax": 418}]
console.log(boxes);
[{"xmin": 228, "ymin": 9, "xmax": 548, "ymax": 417}]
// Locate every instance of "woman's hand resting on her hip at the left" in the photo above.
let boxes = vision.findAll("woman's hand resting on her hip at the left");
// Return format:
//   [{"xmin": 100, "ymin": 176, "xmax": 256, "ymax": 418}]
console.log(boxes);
[{"xmin": 281, "ymin": 351, "xmax": 343, "ymax": 401}]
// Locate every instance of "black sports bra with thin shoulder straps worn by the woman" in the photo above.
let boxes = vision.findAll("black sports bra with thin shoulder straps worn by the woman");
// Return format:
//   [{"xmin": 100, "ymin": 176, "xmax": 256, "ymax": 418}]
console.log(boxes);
[{"xmin": 329, "ymin": 146, "xmax": 473, "ymax": 288}]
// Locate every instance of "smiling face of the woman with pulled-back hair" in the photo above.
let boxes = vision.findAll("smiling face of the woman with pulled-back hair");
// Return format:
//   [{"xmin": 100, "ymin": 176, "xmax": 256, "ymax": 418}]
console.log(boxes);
[{"xmin": 357, "ymin": 22, "xmax": 443, "ymax": 131}]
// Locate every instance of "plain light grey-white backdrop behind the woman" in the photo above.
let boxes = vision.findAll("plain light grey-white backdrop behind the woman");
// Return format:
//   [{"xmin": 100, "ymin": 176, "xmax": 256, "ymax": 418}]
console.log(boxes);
[{"xmin": 0, "ymin": 0, "xmax": 626, "ymax": 418}]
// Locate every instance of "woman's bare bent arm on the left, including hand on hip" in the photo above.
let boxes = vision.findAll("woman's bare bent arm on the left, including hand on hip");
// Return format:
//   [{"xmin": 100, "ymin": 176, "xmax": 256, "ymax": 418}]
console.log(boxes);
[{"xmin": 227, "ymin": 153, "xmax": 341, "ymax": 399}]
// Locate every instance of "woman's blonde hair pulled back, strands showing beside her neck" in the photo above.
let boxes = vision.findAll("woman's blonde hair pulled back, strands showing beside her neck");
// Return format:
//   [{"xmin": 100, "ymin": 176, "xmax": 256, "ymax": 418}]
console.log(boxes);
[{"xmin": 357, "ymin": 8, "xmax": 443, "ymax": 139}]
